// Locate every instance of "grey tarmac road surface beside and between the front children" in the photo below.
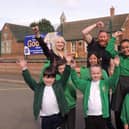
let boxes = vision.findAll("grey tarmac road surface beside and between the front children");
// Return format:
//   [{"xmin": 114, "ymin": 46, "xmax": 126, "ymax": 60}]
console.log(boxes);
[{"xmin": 0, "ymin": 74, "xmax": 84, "ymax": 129}]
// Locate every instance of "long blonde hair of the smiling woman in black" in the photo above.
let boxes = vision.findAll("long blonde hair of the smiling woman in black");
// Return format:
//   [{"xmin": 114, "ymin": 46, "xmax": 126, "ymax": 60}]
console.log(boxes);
[{"xmin": 52, "ymin": 35, "xmax": 66, "ymax": 55}]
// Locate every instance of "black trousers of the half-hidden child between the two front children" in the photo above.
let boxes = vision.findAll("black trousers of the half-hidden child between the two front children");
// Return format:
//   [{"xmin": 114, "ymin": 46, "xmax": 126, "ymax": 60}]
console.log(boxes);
[{"xmin": 61, "ymin": 108, "xmax": 76, "ymax": 129}]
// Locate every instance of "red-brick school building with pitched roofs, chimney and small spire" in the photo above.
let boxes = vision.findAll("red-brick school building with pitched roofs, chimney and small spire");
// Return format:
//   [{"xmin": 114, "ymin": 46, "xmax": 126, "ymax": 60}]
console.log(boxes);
[{"xmin": 0, "ymin": 7, "xmax": 129, "ymax": 59}]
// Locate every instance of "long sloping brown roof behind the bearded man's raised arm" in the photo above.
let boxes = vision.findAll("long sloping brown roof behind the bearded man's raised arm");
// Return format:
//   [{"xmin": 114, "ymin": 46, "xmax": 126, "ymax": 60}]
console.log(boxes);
[{"xmin": 62, "ymin": 14, "xmax": 129, "ymax": 40}]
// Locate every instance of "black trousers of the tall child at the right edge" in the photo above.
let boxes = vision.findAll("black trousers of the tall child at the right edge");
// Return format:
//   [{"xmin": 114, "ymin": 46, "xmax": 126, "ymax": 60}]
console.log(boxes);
[{"xmin": 111, "ymin": 76, "xmax": 129, "ymax": 129}]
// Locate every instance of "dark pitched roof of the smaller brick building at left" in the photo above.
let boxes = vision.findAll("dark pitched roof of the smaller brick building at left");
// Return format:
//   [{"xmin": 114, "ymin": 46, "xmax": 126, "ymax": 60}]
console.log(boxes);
[{"xmin": 5, "ymin": 23, "xmax": 33, "ymax": 42}]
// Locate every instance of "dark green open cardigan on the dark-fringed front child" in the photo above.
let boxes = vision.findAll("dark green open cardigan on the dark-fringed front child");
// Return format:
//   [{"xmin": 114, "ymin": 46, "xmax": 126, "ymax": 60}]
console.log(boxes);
[{"xmin": 23, "ymin": 66, "xmax": 71, "ymax": 119}]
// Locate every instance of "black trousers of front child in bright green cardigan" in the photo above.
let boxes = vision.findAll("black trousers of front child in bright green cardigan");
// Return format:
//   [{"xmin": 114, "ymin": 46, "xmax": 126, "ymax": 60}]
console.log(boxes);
[{"xmin": 85, "ymin": 116, "xmax": 107, "ymax": 129}]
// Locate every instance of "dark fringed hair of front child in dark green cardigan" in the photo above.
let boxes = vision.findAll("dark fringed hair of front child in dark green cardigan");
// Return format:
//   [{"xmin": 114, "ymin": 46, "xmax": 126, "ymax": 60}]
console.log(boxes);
[{"xmin": 43, "ymin": 66, "xmax": 56, "ymax": 78}]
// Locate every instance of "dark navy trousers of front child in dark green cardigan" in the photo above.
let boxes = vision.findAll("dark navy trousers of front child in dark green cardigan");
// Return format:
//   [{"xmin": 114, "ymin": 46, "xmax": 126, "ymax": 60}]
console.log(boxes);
[{"xmin": 41, "ymin": 114, "xmax": 62, "ymax": 129}]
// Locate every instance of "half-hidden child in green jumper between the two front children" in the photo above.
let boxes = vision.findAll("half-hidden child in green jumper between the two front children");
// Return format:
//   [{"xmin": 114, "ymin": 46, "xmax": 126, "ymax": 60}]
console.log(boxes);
[{"xmin": 56, "ymin": 61, "xmax": 76, "ymax": 129}]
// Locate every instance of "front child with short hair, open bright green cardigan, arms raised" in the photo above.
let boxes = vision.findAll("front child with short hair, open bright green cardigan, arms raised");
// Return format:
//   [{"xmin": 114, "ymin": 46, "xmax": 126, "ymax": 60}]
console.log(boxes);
[{"xmin": 71, "ymin": 58, "xmax": 119, "ymax": 129}]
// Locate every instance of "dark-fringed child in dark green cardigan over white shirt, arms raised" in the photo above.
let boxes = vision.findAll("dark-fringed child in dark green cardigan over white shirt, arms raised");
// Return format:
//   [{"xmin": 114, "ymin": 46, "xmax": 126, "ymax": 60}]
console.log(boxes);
[{"xmin": 17, "ymin": 57, "xmax": 71, "ymax": 129}]
